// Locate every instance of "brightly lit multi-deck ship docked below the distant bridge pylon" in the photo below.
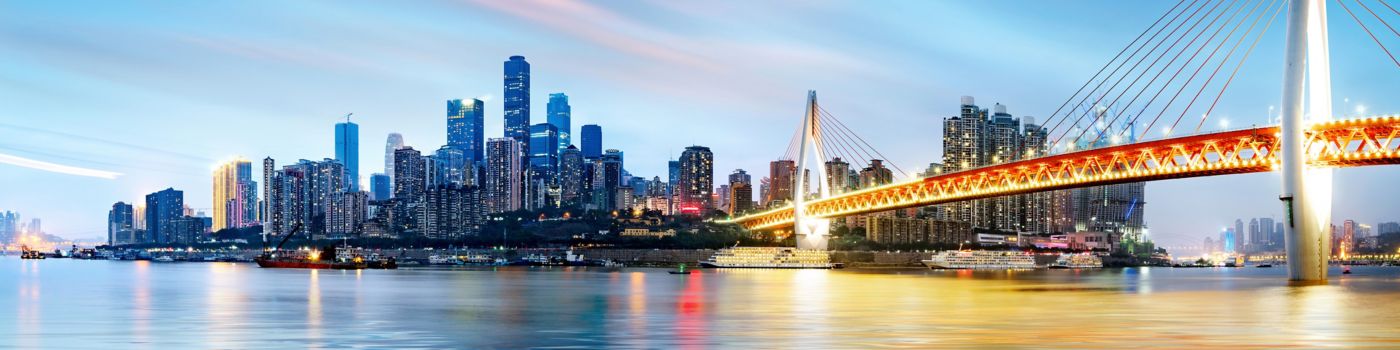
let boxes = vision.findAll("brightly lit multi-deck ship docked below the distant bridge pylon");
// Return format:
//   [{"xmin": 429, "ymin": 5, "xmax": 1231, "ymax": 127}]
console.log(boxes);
[{"xmin": 700, "ymin": 246, "xmax": 841, "ymax": 269}]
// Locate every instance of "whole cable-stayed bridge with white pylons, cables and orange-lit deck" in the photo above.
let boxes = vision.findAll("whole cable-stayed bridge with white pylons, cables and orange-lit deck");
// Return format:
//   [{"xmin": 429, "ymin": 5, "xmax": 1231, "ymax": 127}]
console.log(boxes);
[{"xmin": 720, "ymin": 0, "xmax": 1400, "ymax": 281}]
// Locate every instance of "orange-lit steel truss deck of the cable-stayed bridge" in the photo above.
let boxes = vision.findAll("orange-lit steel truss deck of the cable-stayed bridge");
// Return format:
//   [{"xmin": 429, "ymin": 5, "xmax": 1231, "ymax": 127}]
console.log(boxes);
[{"xmin": 721, "ymin": 116, "xmax": 1400, "ymax": 230}]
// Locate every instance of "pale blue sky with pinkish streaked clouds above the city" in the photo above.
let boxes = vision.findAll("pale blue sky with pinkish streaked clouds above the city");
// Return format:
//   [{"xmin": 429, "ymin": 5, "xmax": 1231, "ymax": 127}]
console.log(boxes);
[{"xmin": 0, "ymin": 0, "xmax": 1400, "ymax": 245}]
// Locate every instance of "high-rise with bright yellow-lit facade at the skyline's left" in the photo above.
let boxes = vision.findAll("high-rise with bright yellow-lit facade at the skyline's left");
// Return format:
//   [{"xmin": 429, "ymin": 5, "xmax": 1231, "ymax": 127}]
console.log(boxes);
[{"xmin": 209, "ymin": 158, "xmax": 257, "ymax": 231}]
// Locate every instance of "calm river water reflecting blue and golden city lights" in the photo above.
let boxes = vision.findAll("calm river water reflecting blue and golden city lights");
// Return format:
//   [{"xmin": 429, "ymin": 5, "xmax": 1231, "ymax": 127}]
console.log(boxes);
[{"xmin": 0, "ymin": 256, "xmax": 1400, "ymax": 349}]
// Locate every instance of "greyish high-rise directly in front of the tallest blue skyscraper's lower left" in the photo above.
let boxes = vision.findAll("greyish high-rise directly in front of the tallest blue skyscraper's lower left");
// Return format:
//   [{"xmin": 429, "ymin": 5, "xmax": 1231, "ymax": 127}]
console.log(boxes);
[{"xmin": 484, "ymin": 137, "xmax": 524, "ymax": 214}]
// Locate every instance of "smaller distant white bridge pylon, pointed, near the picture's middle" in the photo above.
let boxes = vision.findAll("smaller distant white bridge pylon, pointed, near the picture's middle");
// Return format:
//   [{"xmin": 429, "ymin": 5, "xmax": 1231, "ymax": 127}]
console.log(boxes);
[{"xmin": 792, "ymin": 90, "xmax": 832, "ymax": 251}]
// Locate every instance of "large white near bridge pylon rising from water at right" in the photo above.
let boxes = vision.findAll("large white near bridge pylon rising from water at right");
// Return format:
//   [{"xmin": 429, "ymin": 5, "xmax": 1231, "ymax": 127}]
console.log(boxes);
[{"xmin": 1280, "ymin": 0, "xmax": 1331, "ymax": 283}]
